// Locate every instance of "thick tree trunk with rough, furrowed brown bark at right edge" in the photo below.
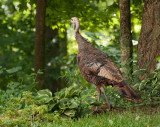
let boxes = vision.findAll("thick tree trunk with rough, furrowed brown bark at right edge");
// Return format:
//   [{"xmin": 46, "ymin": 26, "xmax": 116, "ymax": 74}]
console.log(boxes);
[{"xmin": 137, "ymin": 0, "xmax": 160, "ymax": 80}]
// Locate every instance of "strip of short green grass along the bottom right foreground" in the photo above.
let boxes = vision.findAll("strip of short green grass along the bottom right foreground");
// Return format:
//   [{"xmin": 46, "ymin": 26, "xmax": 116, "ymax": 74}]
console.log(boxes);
[{"xmin": 41, "ymin": 107, "xmax": 160, "ymax": 127}]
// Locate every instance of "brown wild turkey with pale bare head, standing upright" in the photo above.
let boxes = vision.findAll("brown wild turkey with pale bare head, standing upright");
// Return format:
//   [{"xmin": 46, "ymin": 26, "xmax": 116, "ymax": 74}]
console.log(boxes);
[{"xmin": 71, "ymin": 17, "xmax": 142, "ymax": 108}]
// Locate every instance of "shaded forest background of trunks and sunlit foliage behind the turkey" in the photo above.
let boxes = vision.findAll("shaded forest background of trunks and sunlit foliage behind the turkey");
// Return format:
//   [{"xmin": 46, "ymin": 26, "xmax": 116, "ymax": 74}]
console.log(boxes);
[{"xmin": 0, "ymin": 0, "xmax": 160, "ymax": 98}]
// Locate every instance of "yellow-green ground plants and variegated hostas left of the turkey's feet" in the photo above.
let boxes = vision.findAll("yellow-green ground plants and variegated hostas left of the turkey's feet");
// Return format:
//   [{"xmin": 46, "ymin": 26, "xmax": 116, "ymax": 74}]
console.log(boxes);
[{"xmin": 0, "ymin": 85, "xmax": 100, "ymax": 127}]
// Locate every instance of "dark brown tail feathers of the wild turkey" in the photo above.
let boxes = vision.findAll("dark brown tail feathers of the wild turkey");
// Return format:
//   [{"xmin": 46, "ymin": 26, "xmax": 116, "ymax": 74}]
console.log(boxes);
[{"xmin": 114, "ymin": 81, "xmax": 142, "ymax": 103}]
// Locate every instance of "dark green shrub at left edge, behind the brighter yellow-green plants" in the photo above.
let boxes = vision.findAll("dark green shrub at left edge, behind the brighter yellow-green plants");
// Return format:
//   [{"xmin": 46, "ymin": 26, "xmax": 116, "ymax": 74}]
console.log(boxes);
[{"xmin": 0, "ymin": 66, "xmax": 37, "ymax": 105}]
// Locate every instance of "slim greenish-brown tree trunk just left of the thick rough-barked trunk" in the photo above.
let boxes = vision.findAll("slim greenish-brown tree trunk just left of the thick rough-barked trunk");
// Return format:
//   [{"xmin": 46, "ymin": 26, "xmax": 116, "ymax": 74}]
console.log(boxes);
[{"xmin": 119, "ymin": 0, "xmax": 133, "ymax": 77}]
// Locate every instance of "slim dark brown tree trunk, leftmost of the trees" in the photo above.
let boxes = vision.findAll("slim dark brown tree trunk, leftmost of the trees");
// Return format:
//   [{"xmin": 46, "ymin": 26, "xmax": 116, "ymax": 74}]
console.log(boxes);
[{"xmin": 35, "ymin": 0, "xmax": 46, "ymax": 89}]
